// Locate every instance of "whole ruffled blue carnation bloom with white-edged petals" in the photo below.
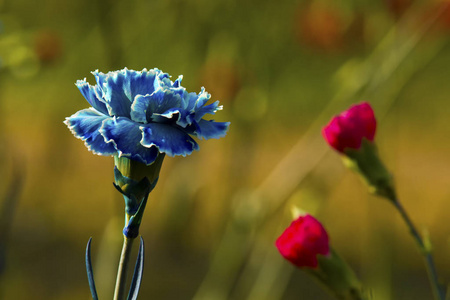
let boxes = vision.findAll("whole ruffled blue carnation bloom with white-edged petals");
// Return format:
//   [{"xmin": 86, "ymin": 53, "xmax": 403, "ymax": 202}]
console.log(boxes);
[{"xmin": 64, "ymin": 68, "xmax": 230, "ymax": 165}]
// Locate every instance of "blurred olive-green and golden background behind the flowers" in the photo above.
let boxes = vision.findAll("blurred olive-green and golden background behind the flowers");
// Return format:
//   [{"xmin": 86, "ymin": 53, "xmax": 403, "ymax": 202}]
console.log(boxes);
[{"xmin": 0, "ymin": 0, "xmax": 450, "ymax": 300}]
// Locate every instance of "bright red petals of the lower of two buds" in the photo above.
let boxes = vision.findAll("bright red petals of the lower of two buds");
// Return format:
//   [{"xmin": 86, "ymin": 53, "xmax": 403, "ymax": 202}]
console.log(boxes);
[{"xmin": 275, "ymin": 215, "xmax": 330, "ymax": 268}]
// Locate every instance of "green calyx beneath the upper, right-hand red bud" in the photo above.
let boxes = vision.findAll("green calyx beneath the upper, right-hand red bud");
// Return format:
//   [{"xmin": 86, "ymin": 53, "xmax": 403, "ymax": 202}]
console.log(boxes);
[{"xmin": 343, "ymin": 139, "xmax": 396, "ymax": 201}]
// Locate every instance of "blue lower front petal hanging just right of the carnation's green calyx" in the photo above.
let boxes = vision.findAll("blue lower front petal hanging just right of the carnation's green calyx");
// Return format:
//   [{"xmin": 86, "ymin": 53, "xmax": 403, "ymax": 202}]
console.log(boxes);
[{"xmin": 140, "ymin": 123, "xmax": 199, "ymax": 156}]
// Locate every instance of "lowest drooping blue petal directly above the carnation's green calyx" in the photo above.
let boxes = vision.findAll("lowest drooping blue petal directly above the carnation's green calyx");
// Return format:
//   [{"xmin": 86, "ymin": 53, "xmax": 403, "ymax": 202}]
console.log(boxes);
[{"xmin": 100, "ymin": 117, "xmax": 158, "ymax": 165}]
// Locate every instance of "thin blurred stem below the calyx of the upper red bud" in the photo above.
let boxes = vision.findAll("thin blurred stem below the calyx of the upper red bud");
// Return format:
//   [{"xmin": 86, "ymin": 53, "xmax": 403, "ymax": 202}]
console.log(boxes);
[{"xmin": 391, "ymin": 199, "xmax": 445, "ymax": 300}]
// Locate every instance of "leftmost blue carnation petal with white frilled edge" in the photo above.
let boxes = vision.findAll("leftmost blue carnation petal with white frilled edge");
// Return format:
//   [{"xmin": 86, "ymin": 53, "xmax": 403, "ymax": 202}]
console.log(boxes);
[{"xmin": 64, "ymin": 108, "xmax": 117, "ymax": 155}]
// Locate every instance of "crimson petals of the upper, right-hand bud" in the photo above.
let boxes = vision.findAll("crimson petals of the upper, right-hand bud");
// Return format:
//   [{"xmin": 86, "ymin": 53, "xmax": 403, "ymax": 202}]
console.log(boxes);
[{"xmin": 322, "ymin": 102, "xmax": 377, "ymax": 152}]
